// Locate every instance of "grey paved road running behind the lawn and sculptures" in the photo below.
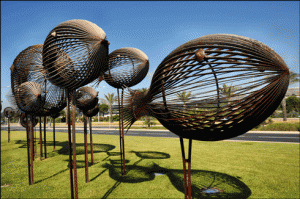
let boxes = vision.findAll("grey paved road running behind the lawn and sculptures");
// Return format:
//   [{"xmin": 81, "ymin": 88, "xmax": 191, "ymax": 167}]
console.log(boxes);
[{"xmin": 1, "ymin": 125, "xmax": 300, "ymax": 143}]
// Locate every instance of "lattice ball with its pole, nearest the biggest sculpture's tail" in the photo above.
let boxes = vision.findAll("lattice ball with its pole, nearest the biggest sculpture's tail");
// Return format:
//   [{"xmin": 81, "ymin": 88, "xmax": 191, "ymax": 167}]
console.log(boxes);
[{"xmin": 102, "ymin": 47, "xmax": 149, "ymax": 175}]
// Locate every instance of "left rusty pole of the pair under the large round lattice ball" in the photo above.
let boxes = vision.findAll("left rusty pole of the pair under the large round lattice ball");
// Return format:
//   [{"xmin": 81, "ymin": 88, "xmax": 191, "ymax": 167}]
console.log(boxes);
[{"xmin": 67, "ymin": 90, "xmax": 74, "ymax": 199}]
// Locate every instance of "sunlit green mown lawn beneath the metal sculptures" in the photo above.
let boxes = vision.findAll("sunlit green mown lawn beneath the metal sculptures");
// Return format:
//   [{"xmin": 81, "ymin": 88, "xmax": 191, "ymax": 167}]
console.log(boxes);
[{"xmin": 1, "ymin": 131, "xmax": 299, "ymax": 198}]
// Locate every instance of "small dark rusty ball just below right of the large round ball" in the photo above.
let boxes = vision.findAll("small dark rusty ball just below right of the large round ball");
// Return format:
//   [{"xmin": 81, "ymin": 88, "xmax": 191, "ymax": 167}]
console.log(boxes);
[{"xmin": 73, "ymin": 87, "xmax": 98, "ymax": 111}]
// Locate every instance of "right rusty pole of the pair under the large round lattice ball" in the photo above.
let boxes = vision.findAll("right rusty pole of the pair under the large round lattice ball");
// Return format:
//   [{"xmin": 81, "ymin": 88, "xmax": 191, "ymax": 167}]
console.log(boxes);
[{"xmin": 72, "ymin": 90, "xmax": 78, "ymax": 199}]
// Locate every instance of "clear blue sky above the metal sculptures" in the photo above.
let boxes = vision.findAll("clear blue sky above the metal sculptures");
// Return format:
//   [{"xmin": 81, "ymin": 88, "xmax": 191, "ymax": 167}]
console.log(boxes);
[{"xmin": 1, "ymin": 1, "xmax": 299, "ymax": 108}]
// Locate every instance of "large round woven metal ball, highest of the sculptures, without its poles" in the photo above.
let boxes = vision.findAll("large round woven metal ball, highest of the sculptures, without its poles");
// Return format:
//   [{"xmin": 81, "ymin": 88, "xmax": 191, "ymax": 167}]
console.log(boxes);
[{"xmin": 43, "ymin": 19, "xmax": 109, "ymax": 90}]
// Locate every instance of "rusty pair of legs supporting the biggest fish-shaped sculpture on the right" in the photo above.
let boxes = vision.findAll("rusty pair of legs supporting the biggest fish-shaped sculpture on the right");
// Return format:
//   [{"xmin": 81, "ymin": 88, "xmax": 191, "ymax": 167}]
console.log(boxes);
[{"xmin": 180, "ymin": 137, "xmax": 192, "ymax": 199}]
